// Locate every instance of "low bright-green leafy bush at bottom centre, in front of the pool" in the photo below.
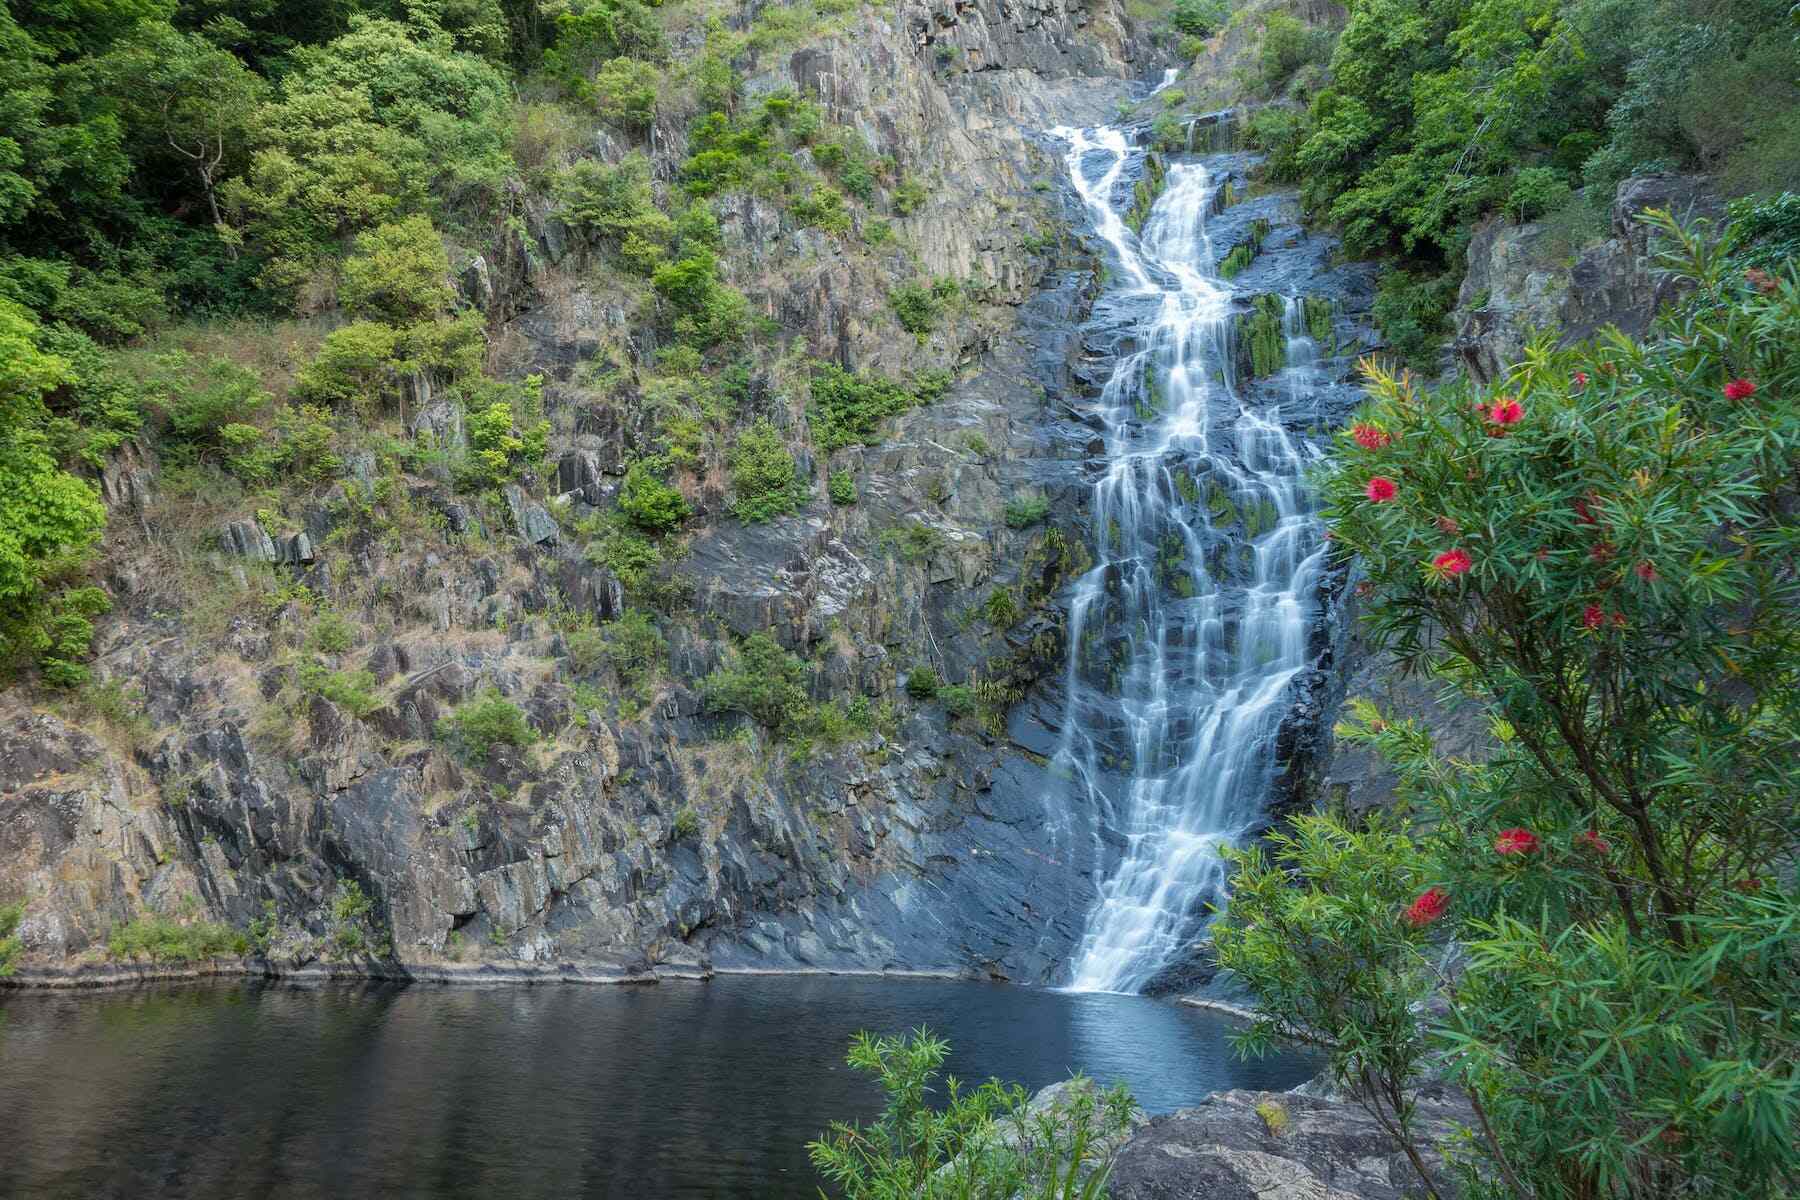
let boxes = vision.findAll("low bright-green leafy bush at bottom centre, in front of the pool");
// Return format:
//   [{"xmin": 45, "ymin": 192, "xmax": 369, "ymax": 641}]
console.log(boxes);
[{"xmin": 806, "ymin": 1029, "xmax": 1136, "ymax": 1200}]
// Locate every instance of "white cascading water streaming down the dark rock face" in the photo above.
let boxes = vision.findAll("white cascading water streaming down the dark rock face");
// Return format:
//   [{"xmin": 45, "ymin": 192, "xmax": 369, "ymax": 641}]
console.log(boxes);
[{"xmin": 1055, "ymin": 115, "xmax": 1323, "ymax": 991}]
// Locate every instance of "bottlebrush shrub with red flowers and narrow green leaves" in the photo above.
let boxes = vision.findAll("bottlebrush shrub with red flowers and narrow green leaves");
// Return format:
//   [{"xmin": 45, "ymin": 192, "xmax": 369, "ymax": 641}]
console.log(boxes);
[{"xmin": 1219, "ymin": 218, "xmax": 1800, "ymax": 1198}]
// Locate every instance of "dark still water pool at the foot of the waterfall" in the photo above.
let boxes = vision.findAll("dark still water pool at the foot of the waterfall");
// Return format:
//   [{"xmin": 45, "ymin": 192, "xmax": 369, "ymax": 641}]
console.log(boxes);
[{"xmin": 0, "ymin": 977, "xmax": 1310, "ymax": 1200}]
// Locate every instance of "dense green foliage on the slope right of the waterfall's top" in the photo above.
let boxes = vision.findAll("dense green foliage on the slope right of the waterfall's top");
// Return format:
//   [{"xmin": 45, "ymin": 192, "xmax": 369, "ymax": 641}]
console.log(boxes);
[{"xmin": 1249, "ymin": 0, "xmax": 1800, "ymax": 367}]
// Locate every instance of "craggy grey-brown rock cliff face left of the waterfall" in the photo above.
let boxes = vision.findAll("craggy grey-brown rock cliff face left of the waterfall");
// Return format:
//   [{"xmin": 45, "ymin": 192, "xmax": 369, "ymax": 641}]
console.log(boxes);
[{"xmin": 0, "ymin": 0, "xmax": 1202, "ymax": 979}]
